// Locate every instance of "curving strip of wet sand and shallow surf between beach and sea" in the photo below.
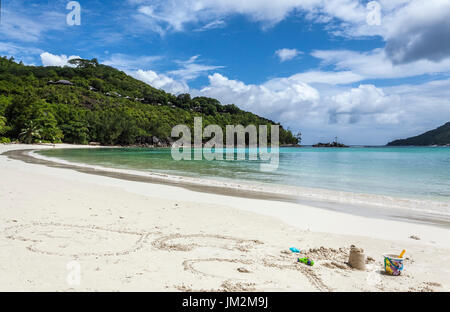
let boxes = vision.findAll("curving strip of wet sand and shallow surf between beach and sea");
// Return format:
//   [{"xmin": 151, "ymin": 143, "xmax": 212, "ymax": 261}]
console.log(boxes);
[{"xmin": 4, "ymin": 145, "xmax": 450, "ymax": 228}]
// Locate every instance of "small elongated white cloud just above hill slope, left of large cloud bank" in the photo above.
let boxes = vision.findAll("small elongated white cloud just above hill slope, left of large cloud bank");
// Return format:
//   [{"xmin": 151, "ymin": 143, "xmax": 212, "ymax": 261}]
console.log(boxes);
[{"xmin": 130, "ymin": 69, "xmax": 189, "ymax": 94}]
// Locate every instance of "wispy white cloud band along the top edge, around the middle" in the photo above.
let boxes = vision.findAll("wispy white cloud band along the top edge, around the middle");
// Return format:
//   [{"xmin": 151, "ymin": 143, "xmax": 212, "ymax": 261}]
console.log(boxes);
[{"xmin": 129, "ymin": 0, "xmax": 365, "ymax": 31}]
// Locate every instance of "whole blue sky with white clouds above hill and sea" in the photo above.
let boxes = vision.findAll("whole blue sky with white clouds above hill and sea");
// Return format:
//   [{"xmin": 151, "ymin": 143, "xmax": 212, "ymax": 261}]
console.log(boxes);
[{"xmin": 0, "ymin": 0, "xmax": 450, "ymax": 144}]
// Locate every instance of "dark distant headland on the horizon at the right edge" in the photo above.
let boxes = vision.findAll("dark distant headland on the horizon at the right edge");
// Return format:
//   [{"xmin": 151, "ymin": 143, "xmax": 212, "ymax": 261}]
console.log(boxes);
[{"xmin": 387, "ymin": 122, "xmax": 450, "ymax": 146}]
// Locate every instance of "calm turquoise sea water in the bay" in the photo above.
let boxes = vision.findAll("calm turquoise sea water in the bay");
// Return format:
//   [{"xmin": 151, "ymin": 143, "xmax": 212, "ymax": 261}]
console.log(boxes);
[{"xmin": 39, "ymin": 147, "xmax": 450, "ymax": 202}]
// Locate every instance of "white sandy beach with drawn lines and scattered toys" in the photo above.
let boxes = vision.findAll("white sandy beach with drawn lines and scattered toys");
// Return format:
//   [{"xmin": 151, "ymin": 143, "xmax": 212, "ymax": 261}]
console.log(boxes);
[{"xmin": 0, "ymin": 145, "xmax": 450, "ymax": 291}]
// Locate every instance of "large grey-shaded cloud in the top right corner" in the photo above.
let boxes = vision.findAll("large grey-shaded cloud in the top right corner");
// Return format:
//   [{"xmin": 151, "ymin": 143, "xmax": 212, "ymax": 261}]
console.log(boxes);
[{"xmin": 324, "ymin": 0, "xmax": 450, "ymax": 64}]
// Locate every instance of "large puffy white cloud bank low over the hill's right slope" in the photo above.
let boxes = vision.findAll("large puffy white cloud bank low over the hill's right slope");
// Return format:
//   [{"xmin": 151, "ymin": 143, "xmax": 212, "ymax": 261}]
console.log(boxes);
[{"xmin": 193, "ymin": 73, "xmax": 403, "ymax": 128}]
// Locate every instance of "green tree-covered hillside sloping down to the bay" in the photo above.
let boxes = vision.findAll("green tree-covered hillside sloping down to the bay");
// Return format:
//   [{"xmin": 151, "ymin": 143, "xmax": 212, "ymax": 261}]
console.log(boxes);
[{"xmin": 0, "ymin": 57, "xmax": 299, "ymax": 145}]
